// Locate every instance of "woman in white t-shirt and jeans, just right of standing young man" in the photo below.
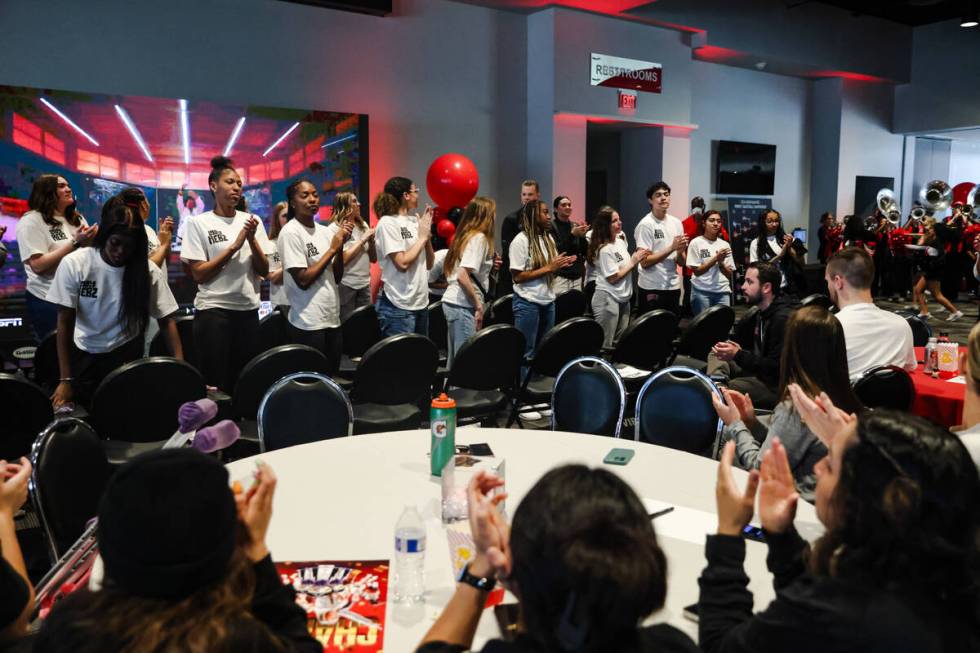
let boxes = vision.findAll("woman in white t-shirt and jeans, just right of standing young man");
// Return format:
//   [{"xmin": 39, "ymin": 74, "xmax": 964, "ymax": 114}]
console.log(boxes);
[{"xmin": 686, "ymin": 211, "xmax": 735, "ymax": 315}]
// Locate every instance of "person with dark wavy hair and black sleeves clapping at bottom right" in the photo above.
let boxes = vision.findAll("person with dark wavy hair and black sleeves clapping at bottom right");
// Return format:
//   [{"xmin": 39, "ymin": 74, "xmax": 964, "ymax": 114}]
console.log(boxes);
[{"xmin": 699, "ymin": 402, "xmax": 980, "ymax": 653}]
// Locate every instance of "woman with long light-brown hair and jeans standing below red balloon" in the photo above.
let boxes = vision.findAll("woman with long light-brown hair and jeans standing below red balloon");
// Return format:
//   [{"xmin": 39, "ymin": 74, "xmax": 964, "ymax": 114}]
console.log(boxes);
[{"xmin": 442, "ymin": 197, "xmax": 497, "ymax": 365}]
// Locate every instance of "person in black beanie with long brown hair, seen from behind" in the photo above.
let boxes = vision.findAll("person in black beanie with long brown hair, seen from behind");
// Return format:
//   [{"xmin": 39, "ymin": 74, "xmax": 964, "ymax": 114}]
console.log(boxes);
[{"xmin": 34, "ymin": 449, "xmax": 322, "ymax": 653}]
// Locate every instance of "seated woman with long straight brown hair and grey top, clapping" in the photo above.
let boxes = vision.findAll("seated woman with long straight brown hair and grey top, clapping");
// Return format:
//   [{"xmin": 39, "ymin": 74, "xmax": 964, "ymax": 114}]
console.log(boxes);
[{"xmin": 711, "ymin": 306, "xmax": 861, "ymax": 502}]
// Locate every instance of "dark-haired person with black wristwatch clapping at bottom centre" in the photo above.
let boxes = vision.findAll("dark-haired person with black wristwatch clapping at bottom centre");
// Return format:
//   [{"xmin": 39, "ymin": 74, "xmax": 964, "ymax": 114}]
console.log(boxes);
[{"xmin": 418, "ymin": 465, "xmax": 698, "ymax": 653}]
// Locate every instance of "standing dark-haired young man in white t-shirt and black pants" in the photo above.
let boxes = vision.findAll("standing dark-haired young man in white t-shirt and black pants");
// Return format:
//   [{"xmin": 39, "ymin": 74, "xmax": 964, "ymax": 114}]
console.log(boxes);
[{"xmin": 633, "ymin": 181, "xmax": 688, "ymax": 314}]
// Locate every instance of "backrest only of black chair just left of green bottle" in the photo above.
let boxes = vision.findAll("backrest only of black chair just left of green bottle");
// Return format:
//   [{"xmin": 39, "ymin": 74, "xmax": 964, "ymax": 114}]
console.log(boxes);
[{"xmin": 351, "ymin": 333, "xmax": 439, "ymax": 406}]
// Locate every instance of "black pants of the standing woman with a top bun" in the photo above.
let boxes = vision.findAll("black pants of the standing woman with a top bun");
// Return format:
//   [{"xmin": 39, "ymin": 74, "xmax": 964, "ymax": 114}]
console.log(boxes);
[{"xmin": 194, "ymin": 308, "xmax": 259, "ymax": 394}]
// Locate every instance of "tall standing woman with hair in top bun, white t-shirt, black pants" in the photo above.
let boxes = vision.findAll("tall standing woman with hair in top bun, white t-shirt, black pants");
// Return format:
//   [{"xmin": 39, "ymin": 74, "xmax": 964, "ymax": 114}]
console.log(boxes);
[{"xmin": 180, "ymin": 156, "xmax": 269, "ymax": 393}]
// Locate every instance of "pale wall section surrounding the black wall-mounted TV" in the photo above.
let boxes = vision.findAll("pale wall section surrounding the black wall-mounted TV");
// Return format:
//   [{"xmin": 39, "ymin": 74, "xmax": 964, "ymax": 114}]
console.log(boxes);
[{"xmin": 673, "ymin": 61, "xmax": 810, "ymax": 226}]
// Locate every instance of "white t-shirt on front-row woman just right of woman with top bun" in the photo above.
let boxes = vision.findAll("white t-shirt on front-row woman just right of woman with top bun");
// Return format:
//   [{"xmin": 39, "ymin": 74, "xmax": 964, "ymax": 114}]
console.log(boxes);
[{"xmin": 279, "ymin": 218, "xmax": 343, "ymax": 331}]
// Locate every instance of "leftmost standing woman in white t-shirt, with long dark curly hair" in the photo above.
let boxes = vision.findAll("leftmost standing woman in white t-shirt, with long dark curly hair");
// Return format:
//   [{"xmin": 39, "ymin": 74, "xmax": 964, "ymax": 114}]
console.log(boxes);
[{"xmin": 16, "ymin": 175, "xmax": 98, "ymax": 342}]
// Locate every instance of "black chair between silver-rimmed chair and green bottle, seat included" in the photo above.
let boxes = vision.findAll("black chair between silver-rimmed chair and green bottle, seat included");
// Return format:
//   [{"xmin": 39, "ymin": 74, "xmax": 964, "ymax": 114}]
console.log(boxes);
[{"xmin": 351, "ymin": 333, "xmax": 439, "ymax": 434}]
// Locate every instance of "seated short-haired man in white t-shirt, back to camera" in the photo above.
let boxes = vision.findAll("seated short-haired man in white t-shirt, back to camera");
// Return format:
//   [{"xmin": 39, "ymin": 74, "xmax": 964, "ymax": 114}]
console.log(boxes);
[{"xmin": 824, "ymin": 247, "xmax": 915, "ymax": 382}]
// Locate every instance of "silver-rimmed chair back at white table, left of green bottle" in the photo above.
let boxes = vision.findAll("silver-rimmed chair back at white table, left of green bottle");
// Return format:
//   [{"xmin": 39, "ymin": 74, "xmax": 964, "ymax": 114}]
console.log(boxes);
[{"xmin": 257, "ymin": 372, "xmax": 354, "ymax": 451}]
